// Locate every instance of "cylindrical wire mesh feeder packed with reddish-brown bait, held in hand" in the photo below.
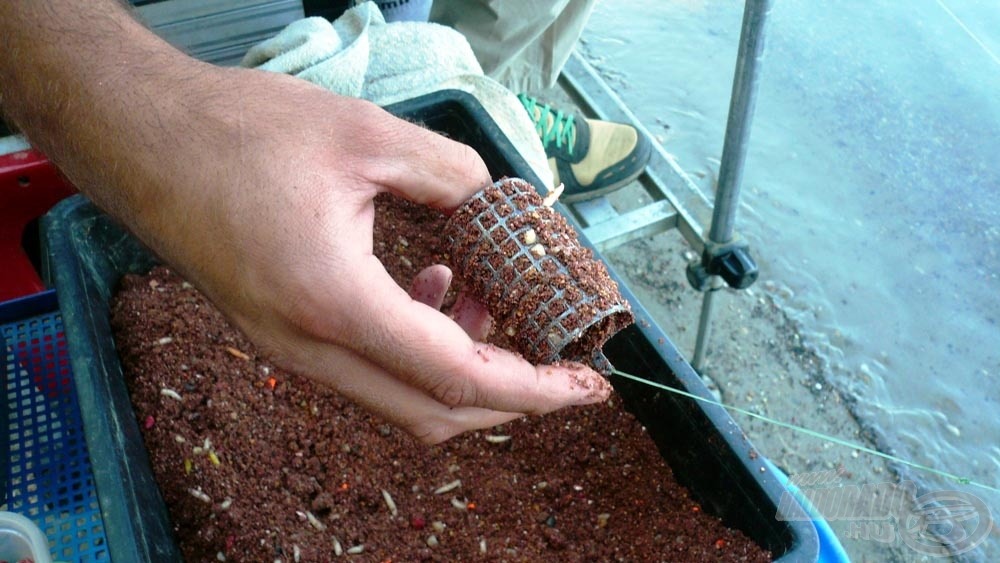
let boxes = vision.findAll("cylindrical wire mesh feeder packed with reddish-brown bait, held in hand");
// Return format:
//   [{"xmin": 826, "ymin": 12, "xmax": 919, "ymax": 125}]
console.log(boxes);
[{"xmin": 444, "ymin": 178, "xmax": 633, "ymax": 375}]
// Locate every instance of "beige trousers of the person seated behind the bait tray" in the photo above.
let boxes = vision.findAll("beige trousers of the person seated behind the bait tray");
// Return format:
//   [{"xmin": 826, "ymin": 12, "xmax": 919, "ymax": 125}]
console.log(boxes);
[{"xmin": 430, "ymin": 0, "xmax": 596, "ymax": 92}]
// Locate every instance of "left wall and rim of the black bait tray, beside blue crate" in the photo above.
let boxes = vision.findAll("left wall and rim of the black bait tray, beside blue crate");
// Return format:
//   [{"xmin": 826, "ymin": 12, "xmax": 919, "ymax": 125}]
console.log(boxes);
[{"xmin": 42, "ymin": 196, "xmax": 182, "ymax": 562}]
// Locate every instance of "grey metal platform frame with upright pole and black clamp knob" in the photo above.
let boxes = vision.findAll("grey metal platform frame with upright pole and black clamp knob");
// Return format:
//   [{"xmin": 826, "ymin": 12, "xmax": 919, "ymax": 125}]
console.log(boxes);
[{"xmin": 559, "ymin": 0, "xmax": 771, "ymax": 371}]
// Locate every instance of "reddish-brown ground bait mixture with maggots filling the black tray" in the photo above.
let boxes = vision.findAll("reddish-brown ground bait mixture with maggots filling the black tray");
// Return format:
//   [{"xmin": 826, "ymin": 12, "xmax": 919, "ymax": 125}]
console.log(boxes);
[{"xmin": 112, "ymin": 196, "xmax": 769, "ymax": 562}]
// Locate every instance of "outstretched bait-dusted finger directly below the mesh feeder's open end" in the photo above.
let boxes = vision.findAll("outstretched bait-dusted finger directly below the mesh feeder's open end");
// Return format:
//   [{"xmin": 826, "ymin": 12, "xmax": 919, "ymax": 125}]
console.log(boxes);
[{"xmin": 346, "ymin": 259, "xmax": 611, "ymax": 414}]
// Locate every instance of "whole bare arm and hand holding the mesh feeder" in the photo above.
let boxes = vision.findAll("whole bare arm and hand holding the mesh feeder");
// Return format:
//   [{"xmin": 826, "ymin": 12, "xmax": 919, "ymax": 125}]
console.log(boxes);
[{"xmin": 0, "ymin": 0, "xmax": 610, "ymax": 443}]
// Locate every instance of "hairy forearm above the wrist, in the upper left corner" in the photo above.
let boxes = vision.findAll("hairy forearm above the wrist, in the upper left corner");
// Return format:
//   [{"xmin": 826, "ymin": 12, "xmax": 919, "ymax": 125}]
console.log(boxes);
[{"xmin": 0, "ymin": 0, "xmax": 179, "ymax": 182}]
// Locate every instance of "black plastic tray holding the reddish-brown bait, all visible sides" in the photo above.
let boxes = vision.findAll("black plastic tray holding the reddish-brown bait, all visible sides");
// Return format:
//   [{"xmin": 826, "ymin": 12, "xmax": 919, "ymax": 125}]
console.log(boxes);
[{"xmin": 43, "ymin": 91, "xmax": 819, "ymax": 562}]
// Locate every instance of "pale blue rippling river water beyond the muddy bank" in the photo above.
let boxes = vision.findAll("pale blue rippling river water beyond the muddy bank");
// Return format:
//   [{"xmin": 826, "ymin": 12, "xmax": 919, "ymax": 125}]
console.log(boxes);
[{"xmin": 582, "ymin": 0, "xmax": 1000, "ymax": 557}]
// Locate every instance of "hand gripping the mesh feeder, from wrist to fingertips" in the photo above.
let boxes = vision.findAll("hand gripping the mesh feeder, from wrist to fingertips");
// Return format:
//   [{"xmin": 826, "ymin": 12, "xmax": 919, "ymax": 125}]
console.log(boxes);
[{"xmin": 140, "ymin": 70, "xmax": 610, "ymax": 442}]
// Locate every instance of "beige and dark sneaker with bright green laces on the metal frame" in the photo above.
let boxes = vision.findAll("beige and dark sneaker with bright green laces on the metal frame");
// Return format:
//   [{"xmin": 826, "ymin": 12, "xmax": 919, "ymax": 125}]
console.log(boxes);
[{"xmin": 517, "ymin": 94, "xmax": 652, "ymax": 203}]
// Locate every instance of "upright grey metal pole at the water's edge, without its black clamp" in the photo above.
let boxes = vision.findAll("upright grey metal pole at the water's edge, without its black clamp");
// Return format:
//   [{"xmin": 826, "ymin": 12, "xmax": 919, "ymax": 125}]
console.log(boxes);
[{"xmin": 692, "ymin": 0, "xmax": 771, "ymax": 371}]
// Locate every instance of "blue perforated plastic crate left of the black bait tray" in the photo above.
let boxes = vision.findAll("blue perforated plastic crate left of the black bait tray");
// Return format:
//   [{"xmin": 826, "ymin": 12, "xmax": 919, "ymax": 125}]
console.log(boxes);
[{"xmin": 0, "ymin": 291, "xmax": 109, "ymax": 561}]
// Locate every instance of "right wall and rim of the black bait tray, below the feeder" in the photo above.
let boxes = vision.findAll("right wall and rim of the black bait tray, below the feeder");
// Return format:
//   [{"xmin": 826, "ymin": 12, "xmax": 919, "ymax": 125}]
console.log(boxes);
[{"xmin": 604, "ymin": 284, "xmax": 819, "ymax": 563}]
